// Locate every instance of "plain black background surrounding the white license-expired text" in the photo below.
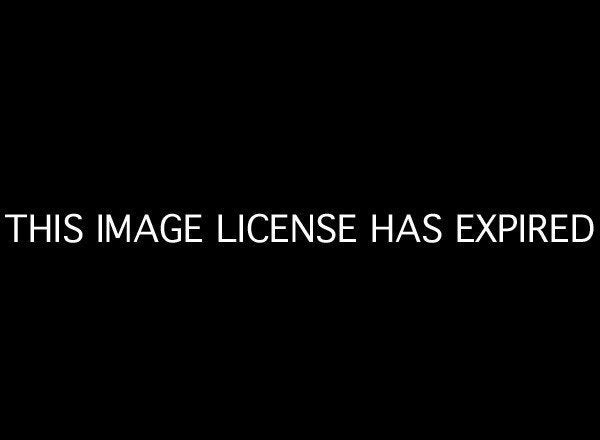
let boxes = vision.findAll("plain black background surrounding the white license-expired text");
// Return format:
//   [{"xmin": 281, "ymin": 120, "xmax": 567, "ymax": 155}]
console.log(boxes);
[{"xmin": 1, "ymin": 5, "xmax": 598, "ymax": 433}]
